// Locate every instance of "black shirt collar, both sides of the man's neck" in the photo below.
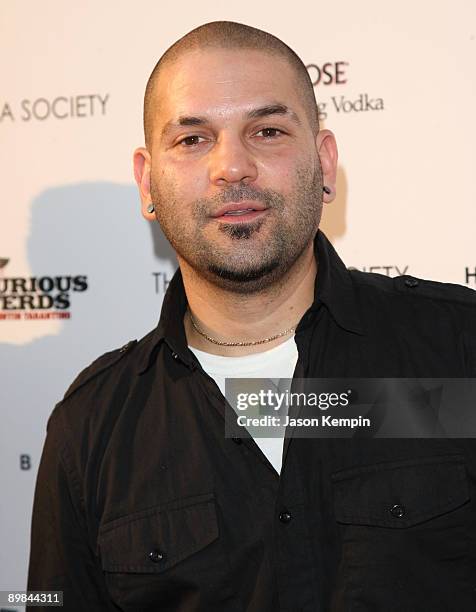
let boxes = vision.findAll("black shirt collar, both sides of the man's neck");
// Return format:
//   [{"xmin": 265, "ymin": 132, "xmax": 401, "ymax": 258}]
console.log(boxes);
[{"xmin": 138, "ymin": 230, "xmax": 364, "ymax": 373}]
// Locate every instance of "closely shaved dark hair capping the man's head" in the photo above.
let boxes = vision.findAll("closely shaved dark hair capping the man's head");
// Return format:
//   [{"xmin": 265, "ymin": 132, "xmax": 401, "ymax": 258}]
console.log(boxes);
[{"xmin": 144, "ymin": 21, "xmax": 319, "ymax": 148}]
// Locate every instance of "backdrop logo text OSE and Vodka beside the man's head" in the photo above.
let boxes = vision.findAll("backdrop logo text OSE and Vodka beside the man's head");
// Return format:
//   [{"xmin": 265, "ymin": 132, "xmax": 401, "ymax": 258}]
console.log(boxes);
[{"xmin": 306, "ymin": 60, "xmax": 385, "ymax": 121}]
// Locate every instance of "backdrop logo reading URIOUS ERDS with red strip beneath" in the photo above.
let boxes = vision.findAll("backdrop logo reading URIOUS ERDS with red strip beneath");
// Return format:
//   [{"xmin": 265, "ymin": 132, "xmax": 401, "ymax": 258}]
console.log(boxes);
[{"xmin": 0, "ymin": 258, "xmax": 88, "ymax": 321}]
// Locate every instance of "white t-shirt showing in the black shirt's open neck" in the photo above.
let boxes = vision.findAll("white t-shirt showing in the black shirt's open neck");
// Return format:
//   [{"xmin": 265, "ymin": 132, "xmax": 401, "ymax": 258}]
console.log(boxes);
[{"xmin": 189, "ymin": 336, "xmax": 298, "ymax": 474}]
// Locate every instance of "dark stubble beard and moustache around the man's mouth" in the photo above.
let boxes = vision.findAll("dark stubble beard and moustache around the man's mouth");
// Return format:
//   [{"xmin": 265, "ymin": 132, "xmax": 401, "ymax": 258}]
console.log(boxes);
[{"xmin": 151, "ymin": 162, "xmax": 322, "ymax": 294}]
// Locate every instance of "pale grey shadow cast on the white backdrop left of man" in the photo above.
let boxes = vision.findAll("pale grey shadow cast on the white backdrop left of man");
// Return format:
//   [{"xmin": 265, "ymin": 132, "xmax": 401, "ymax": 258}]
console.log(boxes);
[{"xmin": 0, "ymin": 182, "xmax": 177, "ymax": 436}]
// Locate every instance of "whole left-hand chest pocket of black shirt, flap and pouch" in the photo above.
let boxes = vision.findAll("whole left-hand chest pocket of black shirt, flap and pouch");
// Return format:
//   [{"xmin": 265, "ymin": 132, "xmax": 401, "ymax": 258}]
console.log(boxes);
[{"xmin": 98, "ymin": 493, "xmax": 234, "ymax": 612}]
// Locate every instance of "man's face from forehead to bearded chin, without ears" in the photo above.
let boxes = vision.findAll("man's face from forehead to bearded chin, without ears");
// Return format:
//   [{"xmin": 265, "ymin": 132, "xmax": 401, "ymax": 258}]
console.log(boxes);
[{"xmin": 139, "ymin": 49, "xmax": 336, "ymax": 293}]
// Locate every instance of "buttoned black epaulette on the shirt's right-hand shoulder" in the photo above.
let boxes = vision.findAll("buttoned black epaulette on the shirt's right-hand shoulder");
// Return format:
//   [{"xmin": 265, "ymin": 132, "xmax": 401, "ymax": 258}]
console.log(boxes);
[{"xmin": 349, "ymin": 269, "xmax": 476, "ymax": 310}]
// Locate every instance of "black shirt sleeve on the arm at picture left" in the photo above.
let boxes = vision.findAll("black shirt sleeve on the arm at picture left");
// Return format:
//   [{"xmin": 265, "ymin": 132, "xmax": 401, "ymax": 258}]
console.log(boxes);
[{"xmin": 26, "ymin": 410, "xmax": 117, "ymax": 612}]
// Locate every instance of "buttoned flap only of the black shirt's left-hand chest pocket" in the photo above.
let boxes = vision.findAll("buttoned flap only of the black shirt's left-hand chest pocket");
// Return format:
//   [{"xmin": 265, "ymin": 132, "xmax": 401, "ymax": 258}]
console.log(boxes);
[{"xmin": 98, "ymin": 493, "xmax": 218, "ymax": 573}]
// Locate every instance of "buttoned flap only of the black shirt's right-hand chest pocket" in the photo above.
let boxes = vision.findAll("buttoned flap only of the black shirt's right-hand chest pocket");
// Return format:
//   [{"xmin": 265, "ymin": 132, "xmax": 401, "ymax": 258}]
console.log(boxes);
[{"xmin": 332, "ymin": 455, "xmax": 470, "ymax": 528}]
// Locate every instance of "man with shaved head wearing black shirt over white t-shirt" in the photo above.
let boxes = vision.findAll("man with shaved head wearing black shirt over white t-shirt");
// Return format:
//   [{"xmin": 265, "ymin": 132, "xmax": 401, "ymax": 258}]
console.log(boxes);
[{"xmin": 28, "ymin": 22, "xmax": 476, "ymax": 612}]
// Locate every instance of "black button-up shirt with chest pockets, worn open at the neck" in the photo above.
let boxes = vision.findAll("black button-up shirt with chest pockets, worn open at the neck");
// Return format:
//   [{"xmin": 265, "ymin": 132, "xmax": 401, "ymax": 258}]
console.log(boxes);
[{"xmin": 28, "ymin": 232, "xmax": 476, "ymax": 612}]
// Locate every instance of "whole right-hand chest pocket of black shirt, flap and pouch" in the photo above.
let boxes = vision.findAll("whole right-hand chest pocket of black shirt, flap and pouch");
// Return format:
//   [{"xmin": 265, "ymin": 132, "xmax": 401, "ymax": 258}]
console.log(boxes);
[{"xmin": 332, "ymin": 454, "xmax": 472, "ymax": 612}]
